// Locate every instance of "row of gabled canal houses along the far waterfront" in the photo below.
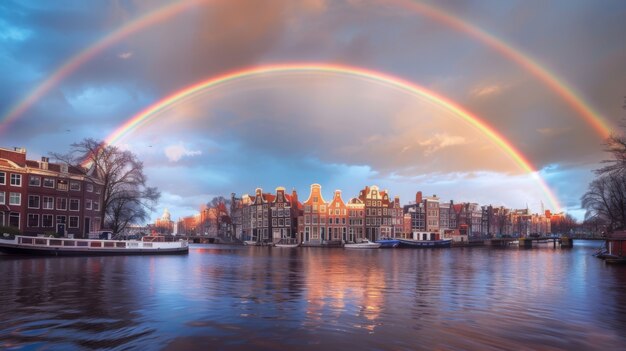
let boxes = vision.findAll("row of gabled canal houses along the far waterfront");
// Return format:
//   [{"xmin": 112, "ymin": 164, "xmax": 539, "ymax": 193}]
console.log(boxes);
[{"xmin": 231, "ymin": 184, "xmax": 550, "ymax": 245}]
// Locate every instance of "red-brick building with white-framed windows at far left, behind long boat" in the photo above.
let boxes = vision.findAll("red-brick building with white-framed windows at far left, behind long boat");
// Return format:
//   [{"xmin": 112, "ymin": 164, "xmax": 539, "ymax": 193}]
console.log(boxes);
[{"xmin": 0, "ymin": 148, "xmax": 102, "ymax": 238}]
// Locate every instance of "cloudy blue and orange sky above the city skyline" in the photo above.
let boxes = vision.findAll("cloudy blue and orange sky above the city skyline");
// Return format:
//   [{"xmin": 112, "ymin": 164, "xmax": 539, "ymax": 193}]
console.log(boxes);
[{"xmin": 0, "ymin": 0, "xmax": 626, "ymax": 223}]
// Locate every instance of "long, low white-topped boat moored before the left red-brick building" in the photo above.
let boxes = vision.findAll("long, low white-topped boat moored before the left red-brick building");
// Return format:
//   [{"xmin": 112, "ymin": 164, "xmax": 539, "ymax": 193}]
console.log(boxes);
[{"xmin": 0, "ymin": 235, "xmax": 189, "ymax": 256}]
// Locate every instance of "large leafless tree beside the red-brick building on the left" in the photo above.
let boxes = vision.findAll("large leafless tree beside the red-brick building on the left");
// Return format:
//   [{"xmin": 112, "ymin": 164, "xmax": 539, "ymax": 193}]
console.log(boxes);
[{"xmin": 52, "ymin": 138, "xmax": 161, "ymax": 233}]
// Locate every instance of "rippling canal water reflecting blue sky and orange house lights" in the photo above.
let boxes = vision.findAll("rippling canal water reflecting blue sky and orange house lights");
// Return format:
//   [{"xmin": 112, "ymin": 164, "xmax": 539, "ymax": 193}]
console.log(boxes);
[{"xmin": 0, "ymin": 241, "xmax": 626, "ymax": 350}]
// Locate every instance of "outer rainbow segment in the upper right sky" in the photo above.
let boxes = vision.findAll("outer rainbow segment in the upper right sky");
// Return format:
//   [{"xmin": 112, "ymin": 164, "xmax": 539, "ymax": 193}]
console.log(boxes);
[{"xmin": 400, "ymin": 0, "xmax": 612, "ymax": 139}]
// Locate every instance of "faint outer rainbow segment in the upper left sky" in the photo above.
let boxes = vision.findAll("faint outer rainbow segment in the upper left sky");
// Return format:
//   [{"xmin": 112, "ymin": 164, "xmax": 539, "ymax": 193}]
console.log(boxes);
[{"xmin": 0, "ymin": 0, "xmax": 207, "ymax": 133}]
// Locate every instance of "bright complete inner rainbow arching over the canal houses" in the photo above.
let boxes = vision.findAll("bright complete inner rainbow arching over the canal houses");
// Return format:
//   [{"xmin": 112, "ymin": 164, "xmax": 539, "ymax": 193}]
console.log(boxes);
[{"xmin": 105, "ymin": 63, "xmax": 561, "ymax": 212}]
